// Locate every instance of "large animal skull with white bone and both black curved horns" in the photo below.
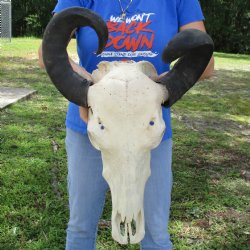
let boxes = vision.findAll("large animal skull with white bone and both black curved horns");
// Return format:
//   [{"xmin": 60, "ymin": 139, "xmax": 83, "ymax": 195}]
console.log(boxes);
[{"xmin": 43, "ymin": 8, "xmax": 213, "ymax": 244}]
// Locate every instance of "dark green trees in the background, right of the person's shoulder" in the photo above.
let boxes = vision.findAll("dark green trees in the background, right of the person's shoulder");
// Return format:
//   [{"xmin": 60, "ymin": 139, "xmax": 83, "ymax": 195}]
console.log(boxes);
[{"xmin": 200, "ymin": 0, "xmax": 250, "ymax": 54}]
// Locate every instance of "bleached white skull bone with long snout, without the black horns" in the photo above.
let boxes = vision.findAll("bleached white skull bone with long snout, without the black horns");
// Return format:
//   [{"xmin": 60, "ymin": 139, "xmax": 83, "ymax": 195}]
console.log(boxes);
[{"xmin": 88, "ymin": 61, "xmax": 168, "ymax": 244}]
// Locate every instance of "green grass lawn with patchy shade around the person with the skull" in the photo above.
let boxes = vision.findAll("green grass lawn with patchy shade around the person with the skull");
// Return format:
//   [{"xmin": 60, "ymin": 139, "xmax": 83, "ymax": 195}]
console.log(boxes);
[{"xmin": 0, "ymin": 38, "xmax": 250, "ymax": 250}]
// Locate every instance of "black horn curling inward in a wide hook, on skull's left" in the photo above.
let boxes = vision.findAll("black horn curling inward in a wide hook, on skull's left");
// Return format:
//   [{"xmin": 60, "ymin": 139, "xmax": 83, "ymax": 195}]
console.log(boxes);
[{"xmin": 42, "ymin": 7, "xmax": 108, "ymax": 107}]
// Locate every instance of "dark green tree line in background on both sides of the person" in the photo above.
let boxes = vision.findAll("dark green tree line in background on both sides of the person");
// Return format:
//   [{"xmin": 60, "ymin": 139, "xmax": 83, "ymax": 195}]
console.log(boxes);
[{"xmin": 12, "ymin": 0, "xmax": 250, "ymax": 54}]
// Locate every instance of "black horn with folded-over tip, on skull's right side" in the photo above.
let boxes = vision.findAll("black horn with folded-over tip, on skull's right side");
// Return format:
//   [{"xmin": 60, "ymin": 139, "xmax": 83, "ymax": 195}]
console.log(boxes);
[{"xmin": 157, "ymin": 29, "xmax": 214, "ymax": 107}]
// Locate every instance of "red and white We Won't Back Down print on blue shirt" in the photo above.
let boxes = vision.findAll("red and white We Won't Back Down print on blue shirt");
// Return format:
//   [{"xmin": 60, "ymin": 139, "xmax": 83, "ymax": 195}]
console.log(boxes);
[{"xmin": 99, "ymin": 13, "xmax": 159, "ymax": 58}]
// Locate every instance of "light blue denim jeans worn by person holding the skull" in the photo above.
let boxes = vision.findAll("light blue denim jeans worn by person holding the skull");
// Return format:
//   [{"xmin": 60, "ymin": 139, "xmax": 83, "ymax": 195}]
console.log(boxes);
[{"xmin": 66, "ymin": 129, "xmax": 172, "ymax": 250}]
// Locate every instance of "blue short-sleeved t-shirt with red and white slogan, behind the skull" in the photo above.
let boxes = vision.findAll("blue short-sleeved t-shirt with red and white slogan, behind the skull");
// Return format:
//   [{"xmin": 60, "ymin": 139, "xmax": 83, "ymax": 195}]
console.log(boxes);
[{"xmin": 53, "ymin": 0, "xmax": 204, "ymax": 140}]
